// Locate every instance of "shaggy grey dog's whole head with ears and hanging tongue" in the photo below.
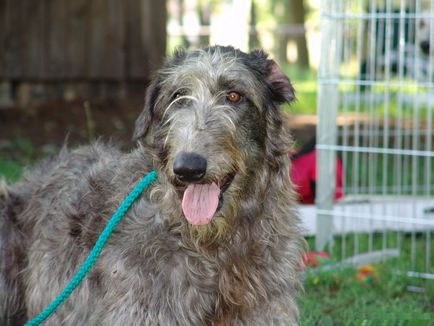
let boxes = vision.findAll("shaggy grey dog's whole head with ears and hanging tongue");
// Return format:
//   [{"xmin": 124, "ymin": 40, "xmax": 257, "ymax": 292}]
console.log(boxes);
[{"xmin": 134, "ymin": 47, "xmax": 294, "ymax": 232}]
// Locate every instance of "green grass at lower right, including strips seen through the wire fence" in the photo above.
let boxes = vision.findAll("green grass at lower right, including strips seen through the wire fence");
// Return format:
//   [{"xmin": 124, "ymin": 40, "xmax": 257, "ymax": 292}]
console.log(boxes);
[{"xmin": 299, "ymin": 232, "xmax": 434, "ymax": 325}]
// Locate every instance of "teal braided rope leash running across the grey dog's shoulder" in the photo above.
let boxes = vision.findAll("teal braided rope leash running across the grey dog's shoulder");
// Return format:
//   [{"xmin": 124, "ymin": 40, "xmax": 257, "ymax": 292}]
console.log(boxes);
[{"xmin": 24, "ymin": 170, "xmax": 157, "ymax": 326}]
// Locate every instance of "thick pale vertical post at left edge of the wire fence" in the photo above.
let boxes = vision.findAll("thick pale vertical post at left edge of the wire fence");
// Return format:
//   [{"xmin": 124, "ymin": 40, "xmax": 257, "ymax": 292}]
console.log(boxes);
[{"xmin": 315, "ymin": 0, "xmax": 342, "ymax": 250}]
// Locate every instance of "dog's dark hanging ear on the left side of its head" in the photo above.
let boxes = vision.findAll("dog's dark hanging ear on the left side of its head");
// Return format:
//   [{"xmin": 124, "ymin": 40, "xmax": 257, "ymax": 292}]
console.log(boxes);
[{"xmin": 133, "ymin": 79, "xmax": 160, "ymax": 141}]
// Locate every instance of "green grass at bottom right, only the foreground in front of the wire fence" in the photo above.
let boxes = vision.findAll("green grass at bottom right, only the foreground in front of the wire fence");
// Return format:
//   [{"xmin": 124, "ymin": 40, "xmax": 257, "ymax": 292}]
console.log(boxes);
[{"xmin": 299, "ymin": 262, "xmax": 434, "ymax": 325}]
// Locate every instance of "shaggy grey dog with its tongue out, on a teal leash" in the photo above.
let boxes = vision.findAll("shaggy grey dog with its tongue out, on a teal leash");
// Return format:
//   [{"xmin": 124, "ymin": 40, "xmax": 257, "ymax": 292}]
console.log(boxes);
[{"xmin": 0, "ymin": 46, "xmax": 304, "ymax": 326}]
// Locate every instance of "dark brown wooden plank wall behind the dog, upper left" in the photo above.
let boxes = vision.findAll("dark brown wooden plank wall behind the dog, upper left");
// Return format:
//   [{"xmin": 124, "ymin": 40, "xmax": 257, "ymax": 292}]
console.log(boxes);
[{"xmin": 0, "ymin": 0, "xmax": 166, "ymax": 104}]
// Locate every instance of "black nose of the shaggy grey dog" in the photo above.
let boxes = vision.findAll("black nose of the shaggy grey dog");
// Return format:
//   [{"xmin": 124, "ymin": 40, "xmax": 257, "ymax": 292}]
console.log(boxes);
[{"xmin": 173, "ymin": 152, "xmax": 207, "ymax": 182}]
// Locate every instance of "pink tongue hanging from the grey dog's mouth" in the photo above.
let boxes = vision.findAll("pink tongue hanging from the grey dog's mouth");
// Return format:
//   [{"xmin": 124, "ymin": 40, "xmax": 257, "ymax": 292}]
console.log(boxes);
[{"xmin": 182, "ymin": 183, "xmax": 220, "ymax": 225}]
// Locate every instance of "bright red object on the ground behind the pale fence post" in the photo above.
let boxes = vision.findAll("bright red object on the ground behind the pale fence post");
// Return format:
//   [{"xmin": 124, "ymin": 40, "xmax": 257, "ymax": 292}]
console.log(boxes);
[{"xmin": 290, "ymin": 150, "xmax": 343, "ymax": 204}]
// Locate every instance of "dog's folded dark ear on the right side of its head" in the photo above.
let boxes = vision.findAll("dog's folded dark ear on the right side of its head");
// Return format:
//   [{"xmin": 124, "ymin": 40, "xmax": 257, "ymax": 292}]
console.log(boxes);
[{"xmin": 267, "ymin": 59, "xmax": 295, "ymax": 104}]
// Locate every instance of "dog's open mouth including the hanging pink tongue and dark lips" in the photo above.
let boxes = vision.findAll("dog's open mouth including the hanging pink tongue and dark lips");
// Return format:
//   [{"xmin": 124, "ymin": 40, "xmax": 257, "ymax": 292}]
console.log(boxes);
[{"xmin": 175, "ymin": 173, "xmax": 235, "ymax": 225}]
